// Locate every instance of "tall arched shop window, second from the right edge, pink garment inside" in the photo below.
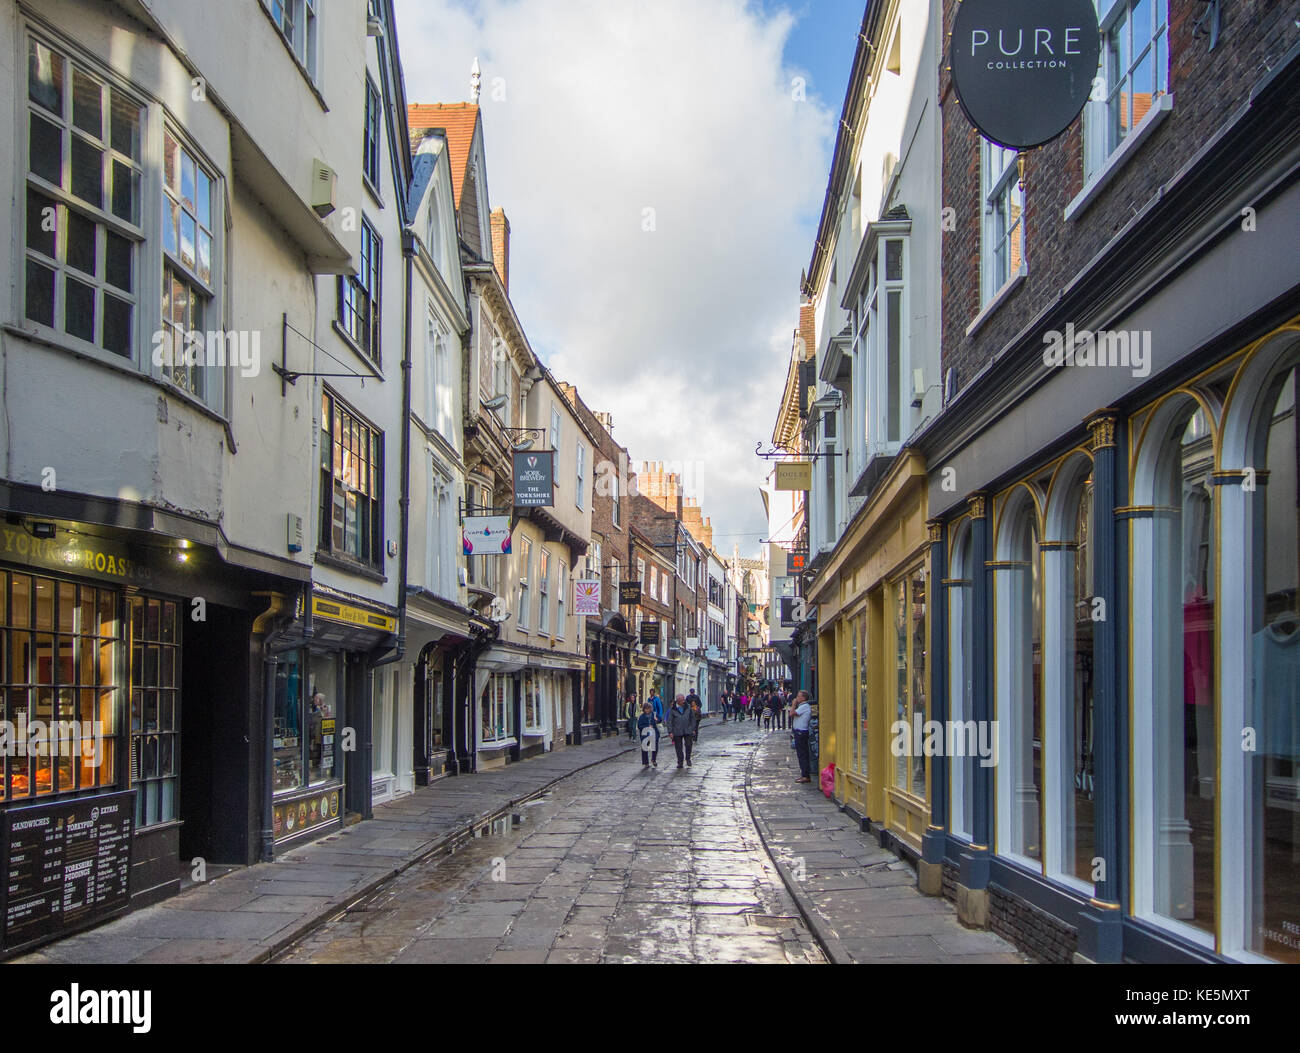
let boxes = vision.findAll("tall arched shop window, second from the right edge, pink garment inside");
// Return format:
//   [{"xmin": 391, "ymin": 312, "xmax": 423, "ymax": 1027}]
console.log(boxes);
[{"xmin": 1131, "ymin": 395, "xmax": 1218, "ymax": 943}]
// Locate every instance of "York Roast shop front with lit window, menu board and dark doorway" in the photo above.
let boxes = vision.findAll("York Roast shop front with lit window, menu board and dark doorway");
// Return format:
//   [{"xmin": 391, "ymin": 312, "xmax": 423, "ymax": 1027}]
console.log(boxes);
[{"xmin": 0, "ymin": 514, "xmax": 297, "ymax": 954}]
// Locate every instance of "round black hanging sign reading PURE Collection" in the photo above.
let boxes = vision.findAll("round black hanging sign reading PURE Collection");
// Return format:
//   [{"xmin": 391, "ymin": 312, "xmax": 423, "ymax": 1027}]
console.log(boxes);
[{"xmin": 952, "ymin": 0, "xmax": 1101, "ymax": 150}]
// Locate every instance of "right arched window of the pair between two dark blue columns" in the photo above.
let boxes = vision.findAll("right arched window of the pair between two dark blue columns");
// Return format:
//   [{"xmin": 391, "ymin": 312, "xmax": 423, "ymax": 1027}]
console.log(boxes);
[{"xmin": 1043, "ymin": 454, "xmax": 1105, "ymax": 891}]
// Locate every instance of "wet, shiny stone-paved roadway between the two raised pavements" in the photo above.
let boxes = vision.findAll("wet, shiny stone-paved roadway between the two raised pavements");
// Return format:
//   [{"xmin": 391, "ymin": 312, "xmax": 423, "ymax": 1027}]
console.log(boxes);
[{"xmin": 277, "ymin": 724, "xmax": 826, "ymax": 963}]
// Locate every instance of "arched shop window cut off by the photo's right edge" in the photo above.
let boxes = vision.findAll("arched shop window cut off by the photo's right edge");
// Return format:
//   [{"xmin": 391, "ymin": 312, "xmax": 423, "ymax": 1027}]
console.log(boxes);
[{"xmin": 1218, "ymin": 345, "xmax": 1300, "ymax": 962}]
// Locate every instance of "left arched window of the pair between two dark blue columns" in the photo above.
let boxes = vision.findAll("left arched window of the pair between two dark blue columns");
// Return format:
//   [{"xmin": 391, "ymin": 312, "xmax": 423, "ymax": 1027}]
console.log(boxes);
[{"xmin": 995, "ymin": 488, "xmax": 1043, "ymax": 861}]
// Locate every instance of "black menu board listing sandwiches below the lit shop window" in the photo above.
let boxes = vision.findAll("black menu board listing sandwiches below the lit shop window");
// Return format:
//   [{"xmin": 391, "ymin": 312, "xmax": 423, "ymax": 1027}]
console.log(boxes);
[{"xmin": 0, "ymin": 790, "xmax": 135, "ymax": 950}]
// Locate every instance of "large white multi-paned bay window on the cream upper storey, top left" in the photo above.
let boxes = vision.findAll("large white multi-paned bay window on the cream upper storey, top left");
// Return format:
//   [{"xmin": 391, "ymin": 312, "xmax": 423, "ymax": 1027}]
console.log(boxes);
[{"xmin": 22, "ymin": 34, "xmax": 233, "ymax": 413}]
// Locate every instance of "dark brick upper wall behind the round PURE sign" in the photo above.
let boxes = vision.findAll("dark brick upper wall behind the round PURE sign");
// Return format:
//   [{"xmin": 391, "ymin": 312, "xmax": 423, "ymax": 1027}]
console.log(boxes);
[{"xmin": 940, "ymin": 0, "xmax": 1300, "ymax": 392}]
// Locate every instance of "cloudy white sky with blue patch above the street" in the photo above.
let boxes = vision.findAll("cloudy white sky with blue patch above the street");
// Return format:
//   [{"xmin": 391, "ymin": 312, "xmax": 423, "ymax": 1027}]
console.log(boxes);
[{"xmin": 397, "ymin": 0, "xmax": 862, "ymax": 555}]
